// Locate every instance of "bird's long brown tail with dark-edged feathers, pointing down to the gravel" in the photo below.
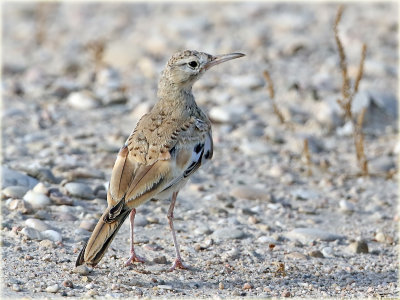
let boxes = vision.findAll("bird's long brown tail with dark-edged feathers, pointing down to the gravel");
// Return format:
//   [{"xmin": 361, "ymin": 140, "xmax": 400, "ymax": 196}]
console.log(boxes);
[{"xmin": 75, "ymin": 208, "xmax": 130, "ymax": 267}]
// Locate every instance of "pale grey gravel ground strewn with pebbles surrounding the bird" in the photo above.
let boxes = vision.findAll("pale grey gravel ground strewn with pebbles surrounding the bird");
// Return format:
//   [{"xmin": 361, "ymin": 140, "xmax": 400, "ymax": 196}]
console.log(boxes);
[{"xmin": 1, "ymin": 2, "xmax": 400, "ymax": 299}]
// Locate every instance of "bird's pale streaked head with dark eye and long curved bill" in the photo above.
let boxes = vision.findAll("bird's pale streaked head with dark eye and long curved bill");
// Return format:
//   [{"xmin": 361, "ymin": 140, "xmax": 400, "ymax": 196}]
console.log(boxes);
[{"xmin": 162, "ymin": 50, "xmax": 244, "ymax": 89}]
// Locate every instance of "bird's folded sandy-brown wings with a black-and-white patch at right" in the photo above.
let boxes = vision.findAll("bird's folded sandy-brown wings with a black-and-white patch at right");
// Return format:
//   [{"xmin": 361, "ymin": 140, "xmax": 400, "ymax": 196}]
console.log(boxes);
[{"xmin": 108, "ymin": 116, "xmax": 213, "ymax": 214}]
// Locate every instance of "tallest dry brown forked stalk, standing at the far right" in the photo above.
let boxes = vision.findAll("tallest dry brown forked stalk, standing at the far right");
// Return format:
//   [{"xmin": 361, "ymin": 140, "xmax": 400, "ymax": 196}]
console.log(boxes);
[{"xmin": 333, "ymin": 5, "xmax": 368, "ymax": 176}]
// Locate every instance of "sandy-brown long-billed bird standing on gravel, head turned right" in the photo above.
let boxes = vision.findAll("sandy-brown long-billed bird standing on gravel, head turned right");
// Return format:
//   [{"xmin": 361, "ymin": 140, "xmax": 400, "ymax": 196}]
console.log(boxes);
[{"xmin": 75, "ymin": 50, "xmax": 245, "ymax": 271}]
